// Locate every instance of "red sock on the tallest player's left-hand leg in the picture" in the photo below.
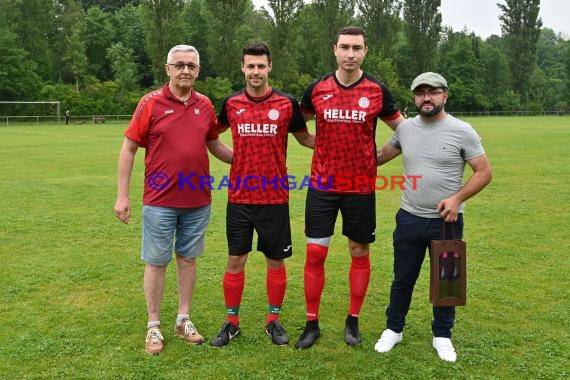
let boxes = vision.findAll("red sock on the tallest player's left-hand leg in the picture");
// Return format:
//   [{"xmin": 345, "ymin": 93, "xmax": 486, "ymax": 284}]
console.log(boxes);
[{"xmin": 305, "ymin": 244, "xmax": 329, "ymax": 321}]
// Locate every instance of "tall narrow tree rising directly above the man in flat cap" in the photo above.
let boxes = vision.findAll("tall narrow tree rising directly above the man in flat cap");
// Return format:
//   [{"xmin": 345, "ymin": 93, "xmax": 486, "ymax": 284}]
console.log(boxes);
[{"xmin": 403, "ymin": 0, "xmax": 441, "ymax": 76}]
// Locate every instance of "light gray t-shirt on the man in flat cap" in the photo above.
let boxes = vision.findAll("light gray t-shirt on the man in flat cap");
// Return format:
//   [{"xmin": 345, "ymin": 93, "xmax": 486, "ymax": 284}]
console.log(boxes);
[{"xmin": 388, "ymin": 115, "xmax": 485, "ymax": 218}]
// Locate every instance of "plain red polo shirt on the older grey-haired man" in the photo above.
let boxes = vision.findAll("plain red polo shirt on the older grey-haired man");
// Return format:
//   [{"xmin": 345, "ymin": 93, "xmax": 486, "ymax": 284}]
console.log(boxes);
[{"xmin": 125, "ymin": 84, "xmax": 218, "ymax": 208}]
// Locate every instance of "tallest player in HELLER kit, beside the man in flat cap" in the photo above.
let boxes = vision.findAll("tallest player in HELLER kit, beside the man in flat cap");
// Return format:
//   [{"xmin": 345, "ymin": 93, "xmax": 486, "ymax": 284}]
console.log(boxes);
[{"xmin": 295, "ymin": 27, "xmax": 404, "ymax": 348}]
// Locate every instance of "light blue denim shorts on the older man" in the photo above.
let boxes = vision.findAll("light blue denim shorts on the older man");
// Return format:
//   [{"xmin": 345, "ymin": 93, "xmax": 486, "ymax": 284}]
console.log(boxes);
[{"xmin": 141, "ymin": 205, "xmax": 211, "ymax": 266}]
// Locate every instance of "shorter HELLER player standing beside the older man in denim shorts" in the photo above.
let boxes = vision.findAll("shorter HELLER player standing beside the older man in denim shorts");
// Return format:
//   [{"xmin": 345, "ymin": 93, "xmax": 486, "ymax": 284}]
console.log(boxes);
[{"xmin": 211, "ymin": 43, "xmax": 315, "ymax": 347}]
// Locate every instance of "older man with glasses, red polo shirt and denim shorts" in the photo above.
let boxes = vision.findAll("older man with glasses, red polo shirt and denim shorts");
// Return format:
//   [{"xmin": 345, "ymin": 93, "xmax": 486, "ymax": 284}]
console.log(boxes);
[{"xmin": 115, "ymin": 45, "xmax": 232, "ymax": 355}]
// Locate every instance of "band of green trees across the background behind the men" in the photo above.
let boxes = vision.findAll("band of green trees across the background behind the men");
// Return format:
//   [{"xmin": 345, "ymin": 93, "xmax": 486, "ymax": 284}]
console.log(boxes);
[{"xmin": 0, "ymin": 0, "xmax": 570, "ymax": 115}]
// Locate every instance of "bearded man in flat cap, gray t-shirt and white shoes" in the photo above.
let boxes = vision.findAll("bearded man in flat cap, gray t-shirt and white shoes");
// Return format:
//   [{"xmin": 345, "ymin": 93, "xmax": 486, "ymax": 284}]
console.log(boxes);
[{"xmin": 374, "ymin": 72, "xmax": 492, "ymax": 362}]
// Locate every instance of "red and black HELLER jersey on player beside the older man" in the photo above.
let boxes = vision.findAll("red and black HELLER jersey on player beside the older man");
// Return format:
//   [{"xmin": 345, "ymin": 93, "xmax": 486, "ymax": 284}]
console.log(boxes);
[{"xmin": 218, "ymin": 89, "xmax": 307, "ymax": 204}]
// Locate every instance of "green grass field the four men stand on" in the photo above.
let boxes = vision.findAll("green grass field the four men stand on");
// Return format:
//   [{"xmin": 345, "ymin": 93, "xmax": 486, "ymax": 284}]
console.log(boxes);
[{"xmin": 0, "ymin": 117, "xmax": 570, "ymax": 379}]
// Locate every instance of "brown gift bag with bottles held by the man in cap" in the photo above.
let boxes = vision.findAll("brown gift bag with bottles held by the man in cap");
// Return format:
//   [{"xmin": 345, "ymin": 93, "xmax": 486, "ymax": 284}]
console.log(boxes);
[{"xmin": 429, "ymin": 239, "xmax": 467, "ymax": 306}]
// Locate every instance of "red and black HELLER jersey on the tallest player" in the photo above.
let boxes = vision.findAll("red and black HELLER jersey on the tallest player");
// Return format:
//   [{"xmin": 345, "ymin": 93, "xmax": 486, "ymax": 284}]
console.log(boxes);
[{"xmin": 301, "ymin": 72, "xmax": 400, "ymax": 194}]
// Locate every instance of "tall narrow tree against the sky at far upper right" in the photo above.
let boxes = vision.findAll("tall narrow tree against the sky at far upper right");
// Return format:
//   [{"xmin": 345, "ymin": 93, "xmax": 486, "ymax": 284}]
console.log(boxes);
[{"xmin": 497, "ymin": 0, "xmax": 542, "ymax": 101}]
